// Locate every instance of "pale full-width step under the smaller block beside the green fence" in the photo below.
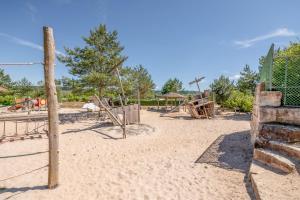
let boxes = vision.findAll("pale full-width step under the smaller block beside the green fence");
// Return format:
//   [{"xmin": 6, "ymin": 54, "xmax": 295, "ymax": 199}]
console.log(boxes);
[{"xmin": 259, "ymin": 106, "xmax": 300, "ymax": 126}]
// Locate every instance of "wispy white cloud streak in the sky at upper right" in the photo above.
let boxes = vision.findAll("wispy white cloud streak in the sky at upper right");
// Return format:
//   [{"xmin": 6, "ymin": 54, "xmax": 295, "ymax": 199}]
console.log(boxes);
[{"xmin": 234, "ymin": 28, "xmax": 297, "ymax": 48}]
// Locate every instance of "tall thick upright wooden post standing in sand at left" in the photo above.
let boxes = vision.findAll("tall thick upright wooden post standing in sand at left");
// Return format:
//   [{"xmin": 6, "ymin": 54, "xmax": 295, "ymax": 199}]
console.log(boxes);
[{"xmin": 43, "ymin": 27, "xmax": 59, "ymax": 189}]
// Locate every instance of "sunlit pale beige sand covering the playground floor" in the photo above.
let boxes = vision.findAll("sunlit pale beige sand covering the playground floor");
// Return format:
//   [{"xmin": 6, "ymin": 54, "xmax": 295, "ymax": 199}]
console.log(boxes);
[{"xmin": 0, "ymin": 111, "xmax": 250, "ymax": 200}]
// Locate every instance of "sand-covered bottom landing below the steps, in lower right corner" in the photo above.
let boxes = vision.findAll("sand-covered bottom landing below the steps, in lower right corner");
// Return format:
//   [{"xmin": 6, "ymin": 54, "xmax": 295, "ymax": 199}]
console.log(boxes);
[{"xmin": 249, "ymin": 161, "xmax": 300, "ymax": 200}]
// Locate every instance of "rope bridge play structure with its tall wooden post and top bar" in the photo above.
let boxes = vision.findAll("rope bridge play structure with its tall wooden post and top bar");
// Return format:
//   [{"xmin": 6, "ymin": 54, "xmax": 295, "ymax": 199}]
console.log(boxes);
[{"xmin": 0, "ymin": 27, "xmax": 59, "ymax": 189}]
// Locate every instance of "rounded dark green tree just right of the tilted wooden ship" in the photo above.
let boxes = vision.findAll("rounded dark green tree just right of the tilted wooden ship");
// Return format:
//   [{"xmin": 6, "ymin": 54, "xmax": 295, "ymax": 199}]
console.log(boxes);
[{"xmin": 210, "ymin": 75, "xmax": 234, "ymax": 106}]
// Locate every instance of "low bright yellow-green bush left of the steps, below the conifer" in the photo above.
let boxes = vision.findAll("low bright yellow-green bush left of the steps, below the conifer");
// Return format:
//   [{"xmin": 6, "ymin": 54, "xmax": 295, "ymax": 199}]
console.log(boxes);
[{"xmin": 224, "ymin": 90, "xmax": 254, "ymax": 112}]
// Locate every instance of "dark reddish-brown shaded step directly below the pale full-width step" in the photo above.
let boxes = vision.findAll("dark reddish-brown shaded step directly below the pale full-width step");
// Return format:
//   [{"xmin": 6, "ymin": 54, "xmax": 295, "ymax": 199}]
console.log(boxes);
[{"xmin": 259, "ymin": 123, "xmax": 300, "ymax": 142}]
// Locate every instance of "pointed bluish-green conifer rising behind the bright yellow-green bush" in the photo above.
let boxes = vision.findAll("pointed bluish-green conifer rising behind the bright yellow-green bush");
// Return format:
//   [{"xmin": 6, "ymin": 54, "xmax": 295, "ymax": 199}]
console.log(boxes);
[{"xmin": 237, "ymin": 65, "xmax": 259, "ymax": 94}]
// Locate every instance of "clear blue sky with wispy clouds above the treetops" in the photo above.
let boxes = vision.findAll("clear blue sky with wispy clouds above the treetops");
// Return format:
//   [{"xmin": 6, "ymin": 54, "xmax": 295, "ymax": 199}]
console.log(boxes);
[{"xmin": 0, "ymin": 0, "xmax": 300, "ymax": 90}]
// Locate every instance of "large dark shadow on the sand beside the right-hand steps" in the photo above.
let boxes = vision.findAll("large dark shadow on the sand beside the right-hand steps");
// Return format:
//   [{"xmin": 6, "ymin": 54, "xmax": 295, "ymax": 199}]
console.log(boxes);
[{"xmin": 195, "ymin": 131, "xmax": 254, "ymax": 199}]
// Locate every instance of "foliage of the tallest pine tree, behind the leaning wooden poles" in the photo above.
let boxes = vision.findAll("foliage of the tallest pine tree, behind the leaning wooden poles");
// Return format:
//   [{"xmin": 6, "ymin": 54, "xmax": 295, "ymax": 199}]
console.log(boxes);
[{"xmin": 58, "ymin": 24, "xmax": 124, "ymax": 96}]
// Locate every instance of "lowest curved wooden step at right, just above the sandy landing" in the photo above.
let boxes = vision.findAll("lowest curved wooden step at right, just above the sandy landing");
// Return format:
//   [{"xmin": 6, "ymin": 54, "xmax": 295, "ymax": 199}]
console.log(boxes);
[{"xmin": 253, "ymin": 148, "xmax": 296, "ymax": 173}]
